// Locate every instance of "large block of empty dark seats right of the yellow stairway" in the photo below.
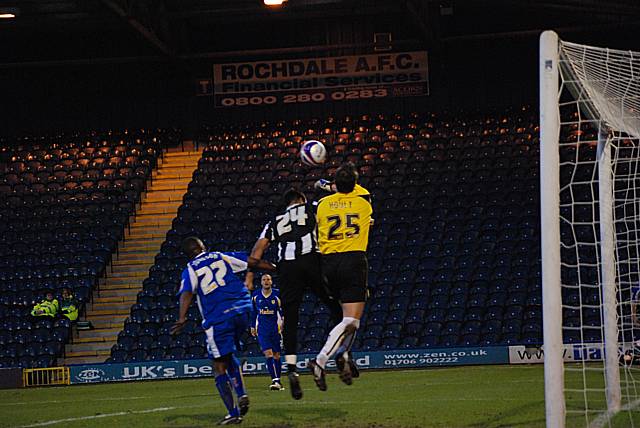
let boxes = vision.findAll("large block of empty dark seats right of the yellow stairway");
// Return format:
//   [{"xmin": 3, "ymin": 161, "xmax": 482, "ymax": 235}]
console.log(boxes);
[{"xmin": 95, "ymin": 109, "xmax": 556, "ymax": 359}]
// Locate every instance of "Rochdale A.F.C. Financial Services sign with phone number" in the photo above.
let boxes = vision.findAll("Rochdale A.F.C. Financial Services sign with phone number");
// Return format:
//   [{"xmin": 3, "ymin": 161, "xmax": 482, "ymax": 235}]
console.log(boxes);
[{"xmin": 213, "ymin": 51, "xmax": 429, "ymax": 107}]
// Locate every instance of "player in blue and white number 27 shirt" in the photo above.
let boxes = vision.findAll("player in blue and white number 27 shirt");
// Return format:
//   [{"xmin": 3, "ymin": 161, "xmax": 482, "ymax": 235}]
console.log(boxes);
[{"xmin": 171, "ymin": 237, "xmax": 275, "ymax": 425}]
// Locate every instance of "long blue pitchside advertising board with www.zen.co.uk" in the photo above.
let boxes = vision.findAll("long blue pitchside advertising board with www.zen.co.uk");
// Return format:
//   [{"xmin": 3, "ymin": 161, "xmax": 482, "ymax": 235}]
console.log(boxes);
[{"xmin": 70, "ymin": 347, "xmax": 509, "ymax": 384}]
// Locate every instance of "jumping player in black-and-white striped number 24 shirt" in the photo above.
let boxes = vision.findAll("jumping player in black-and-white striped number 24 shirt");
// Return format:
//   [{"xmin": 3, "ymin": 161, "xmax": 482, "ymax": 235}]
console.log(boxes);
[{"xmin": 245, "ymin": 189, "xmax": 342, "ymax": 400}]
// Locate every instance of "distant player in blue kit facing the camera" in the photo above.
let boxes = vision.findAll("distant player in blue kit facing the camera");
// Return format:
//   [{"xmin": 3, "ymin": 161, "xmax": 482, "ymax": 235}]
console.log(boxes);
[{"xmin": 251, "ymin": 274, "xmax": 284, "ymax": 391}]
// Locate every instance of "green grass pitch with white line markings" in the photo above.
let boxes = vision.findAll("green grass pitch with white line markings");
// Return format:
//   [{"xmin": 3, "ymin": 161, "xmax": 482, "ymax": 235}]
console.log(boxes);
[{"xmin": 0, "ymin": 365, "xmax": 640, "ymax": 428}]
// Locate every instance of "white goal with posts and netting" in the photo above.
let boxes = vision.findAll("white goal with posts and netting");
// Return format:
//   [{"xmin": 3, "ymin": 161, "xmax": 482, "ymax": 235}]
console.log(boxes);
[{"xmin": 540, "ymin": 32, "xmax": 640, "ymax": 427}]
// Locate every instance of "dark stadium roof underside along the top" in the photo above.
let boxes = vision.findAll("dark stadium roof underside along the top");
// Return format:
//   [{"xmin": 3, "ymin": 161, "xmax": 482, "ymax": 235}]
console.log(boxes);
[{"xmin": 0, "ymin": 0, "xmax": 640, "ymax": 68}]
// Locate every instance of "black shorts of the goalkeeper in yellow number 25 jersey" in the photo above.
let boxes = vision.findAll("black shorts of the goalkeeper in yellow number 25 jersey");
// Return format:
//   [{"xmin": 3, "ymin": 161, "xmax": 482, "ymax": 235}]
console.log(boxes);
[{"xmin": 322, "ymin": 251, "xmax": 369, "ymax": 303}]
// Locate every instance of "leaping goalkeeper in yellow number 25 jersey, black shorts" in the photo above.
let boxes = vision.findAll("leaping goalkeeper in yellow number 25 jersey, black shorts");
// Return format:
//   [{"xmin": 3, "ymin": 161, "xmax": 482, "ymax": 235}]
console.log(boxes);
[{"xmin": 309, "ymin": 163, "xmax": 373, "ymax": 391}]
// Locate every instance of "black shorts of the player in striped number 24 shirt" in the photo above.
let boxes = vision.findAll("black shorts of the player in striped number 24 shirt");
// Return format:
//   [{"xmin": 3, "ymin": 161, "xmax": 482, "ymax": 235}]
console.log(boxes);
[{"xmin": 278, "ymin": 253, "xmax": 329, "ymax": 307}]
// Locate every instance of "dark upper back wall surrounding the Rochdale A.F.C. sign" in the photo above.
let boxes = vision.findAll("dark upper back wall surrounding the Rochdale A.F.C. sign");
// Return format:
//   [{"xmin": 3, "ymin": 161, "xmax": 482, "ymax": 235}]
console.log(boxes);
[{"xmin": 0, "ymin": 39, "xmax": 536, "ymax": 136}]
